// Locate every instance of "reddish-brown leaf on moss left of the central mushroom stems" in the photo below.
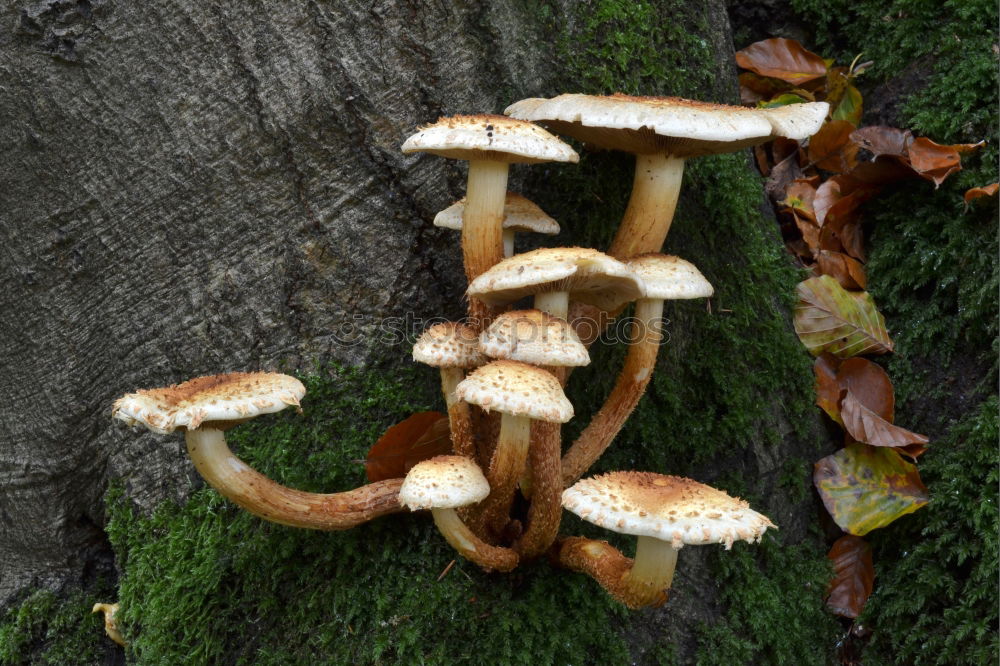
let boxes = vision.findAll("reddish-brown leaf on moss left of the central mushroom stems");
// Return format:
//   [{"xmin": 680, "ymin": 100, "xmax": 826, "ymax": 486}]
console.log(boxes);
[{"xmin": 365, "ymin": 412, "xmax": 452, "ymax": 482}]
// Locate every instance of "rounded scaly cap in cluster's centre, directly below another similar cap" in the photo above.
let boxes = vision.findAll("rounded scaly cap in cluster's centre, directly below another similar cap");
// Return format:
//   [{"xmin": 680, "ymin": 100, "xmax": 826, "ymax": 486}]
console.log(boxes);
[{"xmin": 455, "ymin": 361, "xmax": 573, "ymax": 423}]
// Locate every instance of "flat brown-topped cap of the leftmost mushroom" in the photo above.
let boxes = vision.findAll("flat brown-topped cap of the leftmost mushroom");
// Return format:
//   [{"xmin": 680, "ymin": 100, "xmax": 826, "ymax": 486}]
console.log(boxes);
[{"xmin": 111, "ymin": 372, "xmax": 306, "ymax": 435}]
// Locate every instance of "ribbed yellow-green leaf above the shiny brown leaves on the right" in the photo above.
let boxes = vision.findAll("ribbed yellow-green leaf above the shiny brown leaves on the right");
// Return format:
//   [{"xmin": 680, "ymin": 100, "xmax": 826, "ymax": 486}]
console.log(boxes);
[{"xmin": 794, "ymin": 275, "xmax": 892, "ymax": 358}]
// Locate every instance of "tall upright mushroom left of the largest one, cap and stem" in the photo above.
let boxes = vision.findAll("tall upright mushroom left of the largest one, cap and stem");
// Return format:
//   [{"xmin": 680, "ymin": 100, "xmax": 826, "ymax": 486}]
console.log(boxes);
[{"xmin": 402, "ymin": 114, "xmax": 580, "ymax": 331}]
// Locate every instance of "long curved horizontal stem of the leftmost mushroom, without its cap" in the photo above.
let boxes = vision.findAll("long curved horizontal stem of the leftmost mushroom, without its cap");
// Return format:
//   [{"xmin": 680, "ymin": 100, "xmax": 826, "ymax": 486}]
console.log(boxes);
[{"xmin": 185, "ymin": 428, "xmax": 404, "ymax": 530}]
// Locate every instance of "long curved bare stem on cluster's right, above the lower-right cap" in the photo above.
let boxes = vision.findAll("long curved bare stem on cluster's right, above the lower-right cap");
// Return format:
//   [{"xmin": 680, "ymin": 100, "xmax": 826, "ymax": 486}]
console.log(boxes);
[{"xmin": 562, "ymin": 298, "xmax": 663, "ymax": 487}]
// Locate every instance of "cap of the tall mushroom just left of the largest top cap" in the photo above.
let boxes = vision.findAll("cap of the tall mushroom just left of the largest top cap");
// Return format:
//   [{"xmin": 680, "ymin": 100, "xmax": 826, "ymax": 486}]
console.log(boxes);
[{"xmin": 402, "ymin": 114, "xmax": 580, "ymax": 164}]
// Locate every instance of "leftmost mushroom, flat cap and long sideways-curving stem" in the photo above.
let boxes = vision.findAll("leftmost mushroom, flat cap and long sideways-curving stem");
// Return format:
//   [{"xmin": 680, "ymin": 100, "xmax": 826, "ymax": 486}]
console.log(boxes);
[{"xmin": 118, "ymin": 372, "xmax": 403, "ymax": 530}]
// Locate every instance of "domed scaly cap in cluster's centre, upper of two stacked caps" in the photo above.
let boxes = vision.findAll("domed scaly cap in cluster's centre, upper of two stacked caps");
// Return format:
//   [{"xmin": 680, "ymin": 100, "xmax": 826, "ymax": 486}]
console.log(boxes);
[{"xmin": 479, "ymin": 310, "xmax": 590, "ymax": 366}]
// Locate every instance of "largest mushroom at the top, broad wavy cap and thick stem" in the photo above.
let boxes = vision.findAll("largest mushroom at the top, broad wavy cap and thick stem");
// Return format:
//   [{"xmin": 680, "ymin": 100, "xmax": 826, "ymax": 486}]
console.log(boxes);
[{"xmin": 504, "ymin": 94, "xmax": 829, "ymax": 259}]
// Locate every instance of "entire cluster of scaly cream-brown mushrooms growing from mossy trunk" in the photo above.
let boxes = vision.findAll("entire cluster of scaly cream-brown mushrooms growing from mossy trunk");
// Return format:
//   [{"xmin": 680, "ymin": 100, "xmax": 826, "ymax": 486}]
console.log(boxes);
[{"xmin": 114, "ymin": 95, "xmax": 827, "ymax": 608}]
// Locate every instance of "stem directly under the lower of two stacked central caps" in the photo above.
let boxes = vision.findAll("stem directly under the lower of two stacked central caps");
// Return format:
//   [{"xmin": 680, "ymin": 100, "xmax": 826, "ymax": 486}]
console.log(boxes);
[{"xmin": 483, "ymin": 413, "xmax": 531, "ymax": 534}]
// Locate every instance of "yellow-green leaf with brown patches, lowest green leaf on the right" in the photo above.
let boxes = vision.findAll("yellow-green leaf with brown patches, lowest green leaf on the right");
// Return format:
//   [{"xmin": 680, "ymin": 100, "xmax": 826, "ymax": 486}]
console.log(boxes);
[{"xmin": 813, "ymin": 442, "xmax": 930, "ymax": 536}]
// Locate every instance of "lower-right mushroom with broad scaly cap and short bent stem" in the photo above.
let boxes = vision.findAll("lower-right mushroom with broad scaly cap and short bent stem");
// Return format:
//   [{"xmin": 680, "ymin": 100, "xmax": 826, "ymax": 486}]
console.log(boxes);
[{"xmin": 558, "ymin": 472, "xmax": 774, "ymax": 608}]
